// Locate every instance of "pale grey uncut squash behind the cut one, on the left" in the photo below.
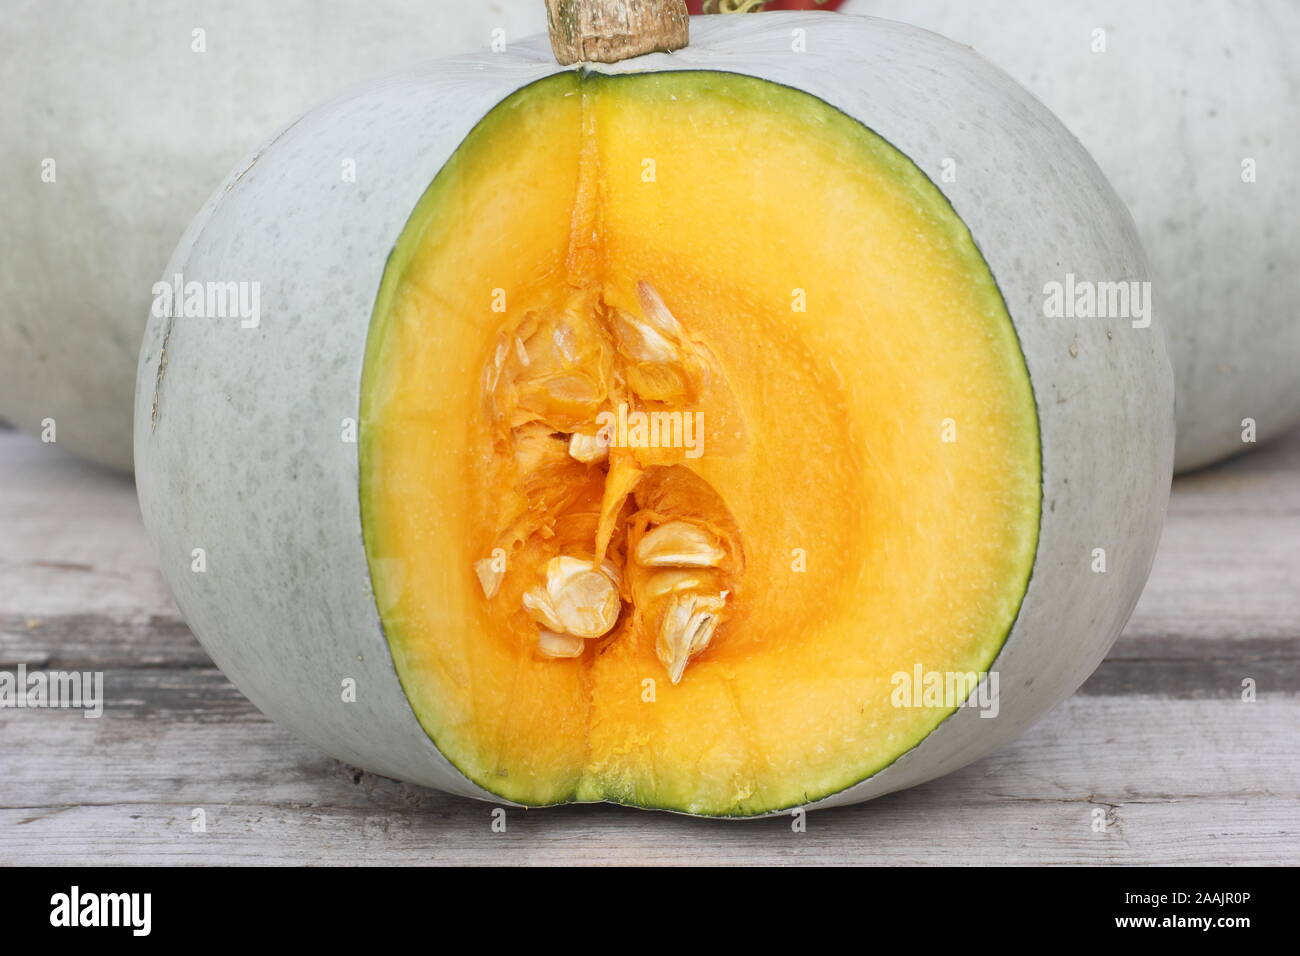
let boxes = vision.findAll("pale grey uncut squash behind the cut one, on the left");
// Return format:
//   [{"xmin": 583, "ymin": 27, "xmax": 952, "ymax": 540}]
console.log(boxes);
[{"xmin": 0, "ymin": 0, "xmax": 546, "ymax": 470}]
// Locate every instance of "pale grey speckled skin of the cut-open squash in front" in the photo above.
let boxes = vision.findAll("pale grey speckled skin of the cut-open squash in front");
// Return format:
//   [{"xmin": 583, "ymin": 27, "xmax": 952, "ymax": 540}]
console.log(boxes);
[{"xmin": 137, "ymin": 13, "xmax": 1174, "ymax": 805}]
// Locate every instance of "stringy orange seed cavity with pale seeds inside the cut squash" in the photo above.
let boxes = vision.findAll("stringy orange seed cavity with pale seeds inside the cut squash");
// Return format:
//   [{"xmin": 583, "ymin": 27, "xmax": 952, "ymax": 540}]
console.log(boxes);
[{"xmin": 475, "ymin": 281, "xmax": 745, "ymax": 684}]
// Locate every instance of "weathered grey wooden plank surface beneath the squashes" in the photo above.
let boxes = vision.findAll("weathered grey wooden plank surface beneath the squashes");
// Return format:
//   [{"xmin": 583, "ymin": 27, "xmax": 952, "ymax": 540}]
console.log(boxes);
[{"xmin": 0, "ymin": 431, "xmax": 1300, "ymax": 865}]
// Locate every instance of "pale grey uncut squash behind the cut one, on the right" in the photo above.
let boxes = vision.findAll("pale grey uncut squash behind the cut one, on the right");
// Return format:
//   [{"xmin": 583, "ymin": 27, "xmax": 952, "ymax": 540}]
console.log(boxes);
[{"xmin": 844, "ymin": 0, "xmax": 1300, "ymax": 471}]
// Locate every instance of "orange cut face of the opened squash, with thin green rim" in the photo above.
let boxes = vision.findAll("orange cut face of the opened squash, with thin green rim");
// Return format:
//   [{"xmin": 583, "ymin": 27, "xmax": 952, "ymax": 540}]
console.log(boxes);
[{"xmin": 360, "ymin": 72, "xmax": 1041, "ymax": 816}]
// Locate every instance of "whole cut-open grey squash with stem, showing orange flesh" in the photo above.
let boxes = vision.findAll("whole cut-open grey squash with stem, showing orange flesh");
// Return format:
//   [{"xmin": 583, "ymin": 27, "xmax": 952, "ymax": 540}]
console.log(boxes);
[{"xmin": 137, "ymin": 0, "xmax": 1173, "ymax": 817}]
